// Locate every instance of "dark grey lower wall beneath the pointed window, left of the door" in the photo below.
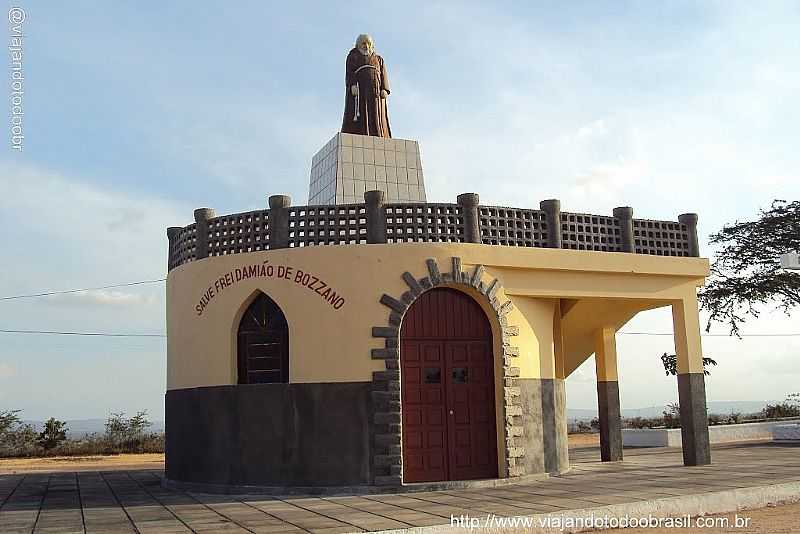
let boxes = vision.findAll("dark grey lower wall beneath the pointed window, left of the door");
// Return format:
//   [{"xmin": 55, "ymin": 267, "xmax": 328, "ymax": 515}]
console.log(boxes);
[{"xmin": 166, "ymin": 382, "xmax": 372, "ymax": 486}]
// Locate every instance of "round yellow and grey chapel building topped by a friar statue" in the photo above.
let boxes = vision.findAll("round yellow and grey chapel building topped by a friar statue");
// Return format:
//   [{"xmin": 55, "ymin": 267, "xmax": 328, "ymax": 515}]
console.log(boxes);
[{"xmin": 165, "ymin": 36, "xmax": 710, "ymax": 492}]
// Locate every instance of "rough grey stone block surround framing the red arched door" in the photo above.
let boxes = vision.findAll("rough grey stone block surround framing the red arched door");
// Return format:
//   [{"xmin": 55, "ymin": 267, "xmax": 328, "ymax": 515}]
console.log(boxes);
[{"xmin": 370, "ymin": 257, "xmax": 525, "ymax": 485}]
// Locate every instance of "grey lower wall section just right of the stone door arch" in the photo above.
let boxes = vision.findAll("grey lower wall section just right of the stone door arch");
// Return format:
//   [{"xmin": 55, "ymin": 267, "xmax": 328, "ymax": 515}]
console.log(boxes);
[{"xmin": 516, "ymin": 378, "xmax": 569, "ymax": 474}]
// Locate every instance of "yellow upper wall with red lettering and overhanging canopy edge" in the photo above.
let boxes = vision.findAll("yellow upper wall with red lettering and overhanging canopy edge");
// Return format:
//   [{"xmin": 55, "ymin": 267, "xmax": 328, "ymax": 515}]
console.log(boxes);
[{"xmin": 167, "ymin": 243, "xmax": 708, "ymax": 389}]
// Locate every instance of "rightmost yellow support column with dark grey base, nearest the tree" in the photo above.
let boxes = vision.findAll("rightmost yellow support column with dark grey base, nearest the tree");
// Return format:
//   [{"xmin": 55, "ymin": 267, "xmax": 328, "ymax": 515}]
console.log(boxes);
[{"xmin": 672, "ymin": 292, "xmax": 711, "ymax": 465}]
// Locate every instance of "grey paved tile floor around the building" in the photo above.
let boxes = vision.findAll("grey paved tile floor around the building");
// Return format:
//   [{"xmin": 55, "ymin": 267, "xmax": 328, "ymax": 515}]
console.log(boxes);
[{"xmin": 0, "ymin": 443, "xmax": 800, "ymax": 534}]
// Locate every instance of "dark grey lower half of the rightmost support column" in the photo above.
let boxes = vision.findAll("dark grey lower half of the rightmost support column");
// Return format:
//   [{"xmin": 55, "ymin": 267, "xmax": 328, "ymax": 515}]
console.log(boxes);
[{"xmin": 678, "ymin": 373, "xmax": 711, "ymax": 465}]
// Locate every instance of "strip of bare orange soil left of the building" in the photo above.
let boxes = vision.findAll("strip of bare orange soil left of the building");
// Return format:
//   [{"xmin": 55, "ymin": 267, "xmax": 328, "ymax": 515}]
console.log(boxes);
[{"xmin": 0, "ymin": 453, "xmax": 164, "ymax": 475}]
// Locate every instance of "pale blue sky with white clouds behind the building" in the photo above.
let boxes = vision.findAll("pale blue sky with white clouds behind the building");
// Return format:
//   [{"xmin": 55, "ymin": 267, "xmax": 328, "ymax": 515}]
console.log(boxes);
[{"xmin": 0, "ymin": 0, "xmax": 800, "ymax": 419}]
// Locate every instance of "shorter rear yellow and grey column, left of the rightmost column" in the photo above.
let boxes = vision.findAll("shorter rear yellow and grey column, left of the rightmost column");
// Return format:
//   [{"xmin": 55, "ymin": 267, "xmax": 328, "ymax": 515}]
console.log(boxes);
[{"xmin": 594, "ymin": 327, "xmax": 622, "ymax": 462}]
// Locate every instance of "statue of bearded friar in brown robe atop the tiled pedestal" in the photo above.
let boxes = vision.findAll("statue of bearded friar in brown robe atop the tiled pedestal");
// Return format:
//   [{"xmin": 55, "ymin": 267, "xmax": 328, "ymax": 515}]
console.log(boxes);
[{"xmin": 342, "ymin": 34, "xmax": 392, "ymax": 137}]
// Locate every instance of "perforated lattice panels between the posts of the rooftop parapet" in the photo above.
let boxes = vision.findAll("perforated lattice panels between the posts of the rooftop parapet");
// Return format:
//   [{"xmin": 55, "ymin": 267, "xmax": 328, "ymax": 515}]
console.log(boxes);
[{"xmin": 168, "ymin": 203, "xmax": 697, "ymax": 270}]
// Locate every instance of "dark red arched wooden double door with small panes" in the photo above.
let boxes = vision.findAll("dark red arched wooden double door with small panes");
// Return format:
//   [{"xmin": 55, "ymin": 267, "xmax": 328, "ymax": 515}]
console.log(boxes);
[{"xmin": 400, "ymin": 288, "xmax": 497, "ymax": 482}]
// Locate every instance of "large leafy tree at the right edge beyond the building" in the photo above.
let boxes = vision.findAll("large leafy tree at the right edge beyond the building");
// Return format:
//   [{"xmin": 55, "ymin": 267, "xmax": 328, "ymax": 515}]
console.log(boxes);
[{"xmin": 698, "ymin": 200, "xmax": 800, "ymax": 336}]
